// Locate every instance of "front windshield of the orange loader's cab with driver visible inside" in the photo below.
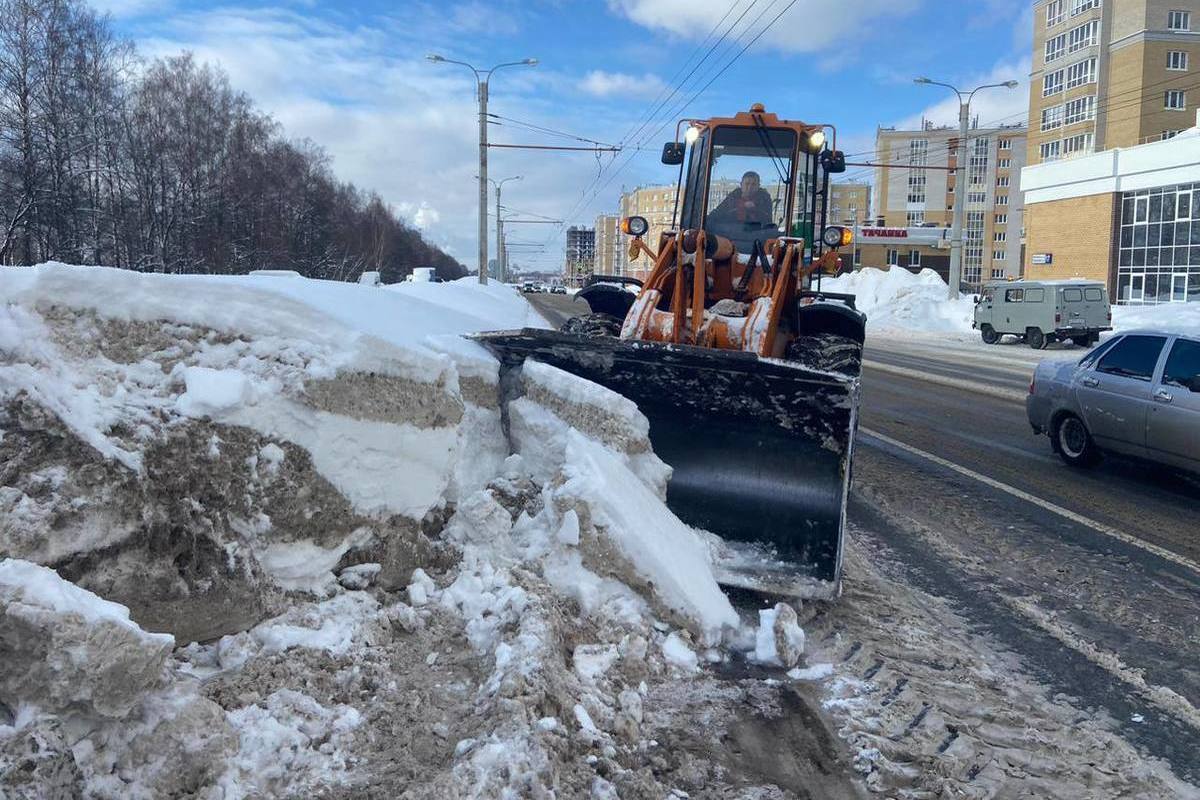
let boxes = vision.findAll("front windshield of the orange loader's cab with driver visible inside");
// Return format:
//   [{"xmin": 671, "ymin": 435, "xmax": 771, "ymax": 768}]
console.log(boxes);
[{"xmin": 704, "ymin": 127, "xmax": 796, "ymax": 253}]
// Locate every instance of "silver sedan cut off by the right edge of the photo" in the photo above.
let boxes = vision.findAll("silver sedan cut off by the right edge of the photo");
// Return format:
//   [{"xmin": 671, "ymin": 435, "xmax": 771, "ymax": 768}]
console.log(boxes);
[{"xmin": 1025, "ymin": 331, "xmax": 1200, "ymax": 473}]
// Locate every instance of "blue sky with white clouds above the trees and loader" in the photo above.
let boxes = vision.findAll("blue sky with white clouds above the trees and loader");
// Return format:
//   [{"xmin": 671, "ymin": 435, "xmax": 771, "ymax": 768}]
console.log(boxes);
[{"xmin": 96, "ymin": 0, "xmax": 1032, "ymax": 267}]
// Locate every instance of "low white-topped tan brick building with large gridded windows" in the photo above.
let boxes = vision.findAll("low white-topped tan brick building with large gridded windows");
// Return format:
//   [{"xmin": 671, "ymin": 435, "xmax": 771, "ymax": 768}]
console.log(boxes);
[{"xmin": 1021, "ymin": 116, "xmax": 1200, "ymax": 305}]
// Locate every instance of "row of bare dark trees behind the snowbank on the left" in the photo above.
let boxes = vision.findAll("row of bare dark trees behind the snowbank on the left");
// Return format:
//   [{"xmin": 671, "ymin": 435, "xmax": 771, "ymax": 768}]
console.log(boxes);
[{"xmin": 0, "ymin": 0, "xmax": 467, "ymax": 283}]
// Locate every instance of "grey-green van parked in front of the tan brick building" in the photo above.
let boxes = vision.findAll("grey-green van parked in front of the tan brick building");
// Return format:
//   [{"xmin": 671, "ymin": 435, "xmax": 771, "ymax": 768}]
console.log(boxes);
[{"xmin": 971, "ymin": 281, "xmax": 1112, "ymax": 350}]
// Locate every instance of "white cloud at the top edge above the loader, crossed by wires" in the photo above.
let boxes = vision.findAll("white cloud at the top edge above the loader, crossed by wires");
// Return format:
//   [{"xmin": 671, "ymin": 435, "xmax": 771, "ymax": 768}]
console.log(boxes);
[{"xmin": 608, "ymin": 0, "xmax": 923, "ymax": 53}]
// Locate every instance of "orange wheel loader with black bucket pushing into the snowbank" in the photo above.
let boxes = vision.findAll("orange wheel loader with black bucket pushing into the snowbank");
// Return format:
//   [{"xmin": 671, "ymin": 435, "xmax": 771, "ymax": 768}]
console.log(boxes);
[{"xmin": 475, "ymin": 104, "xmax": 865, "ymax": 597}]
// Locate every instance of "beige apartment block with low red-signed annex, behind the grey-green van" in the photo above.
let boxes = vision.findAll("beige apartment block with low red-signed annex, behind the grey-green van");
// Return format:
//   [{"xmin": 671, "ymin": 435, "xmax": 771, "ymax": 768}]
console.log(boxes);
[{"xmin": 856, "ymin": 125, "xmax": 1026, "ymax": 285}]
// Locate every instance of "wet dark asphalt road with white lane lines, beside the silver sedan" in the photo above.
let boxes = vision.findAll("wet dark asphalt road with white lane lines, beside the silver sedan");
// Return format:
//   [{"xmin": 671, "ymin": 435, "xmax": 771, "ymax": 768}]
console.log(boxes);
[{"xmin": 529, "ymin": 295, "xmax": 1200, "ymax": 783}]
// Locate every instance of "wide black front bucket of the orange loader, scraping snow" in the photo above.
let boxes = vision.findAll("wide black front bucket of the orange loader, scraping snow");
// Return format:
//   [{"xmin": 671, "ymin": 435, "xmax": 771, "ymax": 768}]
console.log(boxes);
[{"xmin": 473, "ymin": 329, "xmax": 859, "ymax": 597}]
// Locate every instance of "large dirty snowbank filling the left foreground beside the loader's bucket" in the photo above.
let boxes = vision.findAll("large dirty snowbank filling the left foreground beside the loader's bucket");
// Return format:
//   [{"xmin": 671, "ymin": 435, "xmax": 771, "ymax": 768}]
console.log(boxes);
[{"xmin": 0, "ymin": 264, "xmax": 811, "ymax": 799}]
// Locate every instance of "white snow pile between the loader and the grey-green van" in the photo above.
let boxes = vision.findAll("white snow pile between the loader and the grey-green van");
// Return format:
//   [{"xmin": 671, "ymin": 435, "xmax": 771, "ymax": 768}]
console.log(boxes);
[{"xmin": 821, "ymin": 267, "xmax": 974, "ymax": 333}]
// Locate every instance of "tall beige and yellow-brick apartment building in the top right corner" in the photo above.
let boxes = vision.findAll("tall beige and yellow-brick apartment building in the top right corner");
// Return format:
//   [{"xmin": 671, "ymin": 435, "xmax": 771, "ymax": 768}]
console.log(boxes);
[{"xmin": 1027, "ymin": 0, "xmax": 1200, "ymax": 164}]
